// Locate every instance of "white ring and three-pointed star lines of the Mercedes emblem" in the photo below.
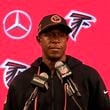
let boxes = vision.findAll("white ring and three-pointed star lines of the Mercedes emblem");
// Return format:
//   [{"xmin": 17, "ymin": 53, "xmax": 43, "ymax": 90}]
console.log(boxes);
[{"xmin": 3, "ymin": 10, "xmax": 32, "ymax": 40}]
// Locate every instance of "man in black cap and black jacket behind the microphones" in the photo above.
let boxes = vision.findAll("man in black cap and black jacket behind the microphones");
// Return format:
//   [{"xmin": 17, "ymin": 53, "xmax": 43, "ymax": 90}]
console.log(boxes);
[{"xmin": 4, "ymin": 14, "xmax": 110, "ymax": 110}]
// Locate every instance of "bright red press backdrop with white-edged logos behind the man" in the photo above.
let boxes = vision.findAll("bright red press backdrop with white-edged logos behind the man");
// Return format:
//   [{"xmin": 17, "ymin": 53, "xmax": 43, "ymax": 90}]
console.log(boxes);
[{"xmin": 0, "ymin": 0, "xmax": 110, "ymax": 110}]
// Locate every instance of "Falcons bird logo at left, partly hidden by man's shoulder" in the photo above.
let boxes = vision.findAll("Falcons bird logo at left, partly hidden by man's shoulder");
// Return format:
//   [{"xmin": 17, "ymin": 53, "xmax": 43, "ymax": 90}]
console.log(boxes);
[{"xmin": 0, "ymin": 59, "xmax": 29, "ymax": 88}]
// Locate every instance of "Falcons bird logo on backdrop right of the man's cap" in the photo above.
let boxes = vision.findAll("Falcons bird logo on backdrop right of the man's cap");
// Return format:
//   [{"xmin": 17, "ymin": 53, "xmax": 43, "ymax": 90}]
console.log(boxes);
[{"xmin": 65, "ymin": 11, "xmax": 96, "ymax": 41}]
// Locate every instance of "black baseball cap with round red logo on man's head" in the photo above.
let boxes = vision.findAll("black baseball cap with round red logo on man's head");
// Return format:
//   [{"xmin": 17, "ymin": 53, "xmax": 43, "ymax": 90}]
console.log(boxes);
[{"xmin": 38, "ymin": 14, "xmax": 72, "ymax": 35}]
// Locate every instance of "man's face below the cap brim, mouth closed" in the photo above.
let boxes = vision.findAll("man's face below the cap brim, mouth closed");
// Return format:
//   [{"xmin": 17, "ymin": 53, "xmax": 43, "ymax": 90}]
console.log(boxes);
[{"xmin": 39, "ymin": 29, "xmax": 68, "ymax": 60}]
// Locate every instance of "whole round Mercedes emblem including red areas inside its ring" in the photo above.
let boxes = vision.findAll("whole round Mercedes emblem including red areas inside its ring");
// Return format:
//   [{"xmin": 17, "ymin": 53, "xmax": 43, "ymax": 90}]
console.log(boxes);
[{"xmin": 3, "ymin": 10, "xmax": 32, "ymax": 39}]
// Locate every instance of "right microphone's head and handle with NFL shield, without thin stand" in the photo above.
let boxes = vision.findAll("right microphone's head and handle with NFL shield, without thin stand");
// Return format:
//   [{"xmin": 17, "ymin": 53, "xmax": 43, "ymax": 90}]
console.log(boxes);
[{"xmin": 55, "ymin": 61, "xmax": 81, "ymax": 96}]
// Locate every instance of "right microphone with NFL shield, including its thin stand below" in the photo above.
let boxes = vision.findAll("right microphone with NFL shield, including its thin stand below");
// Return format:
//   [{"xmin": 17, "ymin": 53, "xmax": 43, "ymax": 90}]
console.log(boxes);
[{"xmin": 55, "ymin": 61, "xmax": 83, "ymax": 110}]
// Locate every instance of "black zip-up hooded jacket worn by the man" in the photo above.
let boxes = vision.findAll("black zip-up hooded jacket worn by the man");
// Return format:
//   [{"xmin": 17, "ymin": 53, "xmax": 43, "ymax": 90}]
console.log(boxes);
[{"xmin": 4, "ymin": 56, "xmax": 110, "ymax": 110}]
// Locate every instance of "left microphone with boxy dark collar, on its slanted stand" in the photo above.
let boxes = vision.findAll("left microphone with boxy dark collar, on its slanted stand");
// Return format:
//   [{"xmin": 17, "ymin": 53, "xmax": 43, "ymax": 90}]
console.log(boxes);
[{"xmin": 23, "ymin": 72, "xmax": 49, "ymax": 110}]
